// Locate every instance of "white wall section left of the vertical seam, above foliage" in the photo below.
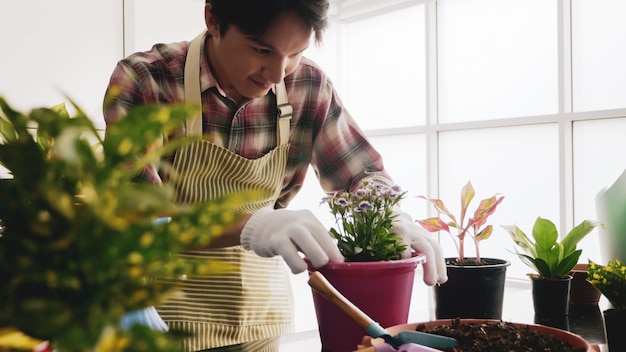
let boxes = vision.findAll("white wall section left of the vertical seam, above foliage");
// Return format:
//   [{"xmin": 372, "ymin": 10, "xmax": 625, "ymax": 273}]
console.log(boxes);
[{"xmin": 0, "ymin": 0, "xmax": 123, "ymax": 127}]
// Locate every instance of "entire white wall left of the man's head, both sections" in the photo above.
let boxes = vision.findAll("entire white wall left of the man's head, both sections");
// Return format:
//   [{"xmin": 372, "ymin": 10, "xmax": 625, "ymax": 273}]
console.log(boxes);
[{"xmin": 0, "ymin": 0, "xmax": 204, "ymax": 128}]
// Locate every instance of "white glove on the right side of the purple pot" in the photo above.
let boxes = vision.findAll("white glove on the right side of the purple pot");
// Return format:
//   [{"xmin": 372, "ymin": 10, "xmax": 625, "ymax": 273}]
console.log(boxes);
[{"xmin": 390, "ymin": 209, "xmax": 448, "ymax": 286}]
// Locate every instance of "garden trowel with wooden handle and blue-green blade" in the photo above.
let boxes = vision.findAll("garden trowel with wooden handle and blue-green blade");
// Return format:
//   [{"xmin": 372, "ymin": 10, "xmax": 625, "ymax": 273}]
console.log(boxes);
[{"xmin": 309, "ymin": 271, "xmax": 457, "ymax": 351}]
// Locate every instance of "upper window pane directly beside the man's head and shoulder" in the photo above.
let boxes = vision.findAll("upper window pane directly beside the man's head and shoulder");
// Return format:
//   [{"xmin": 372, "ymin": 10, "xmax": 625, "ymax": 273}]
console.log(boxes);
[{"xmin": 341, "ymin": 5, "xmax": 426, "ymax": 129}]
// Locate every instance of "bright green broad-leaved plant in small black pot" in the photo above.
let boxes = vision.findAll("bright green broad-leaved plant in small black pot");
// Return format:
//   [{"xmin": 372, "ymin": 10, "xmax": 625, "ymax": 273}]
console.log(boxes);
[{"xmin": 502, "ymin": 217, "xmax": 600, "ymax": 279}]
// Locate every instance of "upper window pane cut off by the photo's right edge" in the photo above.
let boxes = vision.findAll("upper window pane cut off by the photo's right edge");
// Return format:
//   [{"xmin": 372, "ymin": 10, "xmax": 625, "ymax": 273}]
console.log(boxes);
[{"xmin": 572, "ymin": 0, "xmax": 626, "ymax": 111}]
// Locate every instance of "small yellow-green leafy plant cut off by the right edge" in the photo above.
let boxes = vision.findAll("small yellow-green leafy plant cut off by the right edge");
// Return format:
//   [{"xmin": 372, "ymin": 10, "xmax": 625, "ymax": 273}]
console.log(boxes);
[{"xmin": 587, "ymin": 259, "xmax": 626, "ymax": 311}]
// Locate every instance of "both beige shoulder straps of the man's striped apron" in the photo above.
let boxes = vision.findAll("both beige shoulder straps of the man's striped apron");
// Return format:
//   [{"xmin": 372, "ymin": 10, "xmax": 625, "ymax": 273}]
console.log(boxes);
[{"xmin": 184, "ymin": 31, "xmax": 293, "ymax": 145}]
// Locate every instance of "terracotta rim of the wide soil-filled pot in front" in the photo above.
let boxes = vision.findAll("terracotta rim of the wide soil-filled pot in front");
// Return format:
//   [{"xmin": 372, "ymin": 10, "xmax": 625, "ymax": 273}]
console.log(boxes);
[{"xmin": 371, "ymin": 319, "xmax": 592, "ymax": 352}]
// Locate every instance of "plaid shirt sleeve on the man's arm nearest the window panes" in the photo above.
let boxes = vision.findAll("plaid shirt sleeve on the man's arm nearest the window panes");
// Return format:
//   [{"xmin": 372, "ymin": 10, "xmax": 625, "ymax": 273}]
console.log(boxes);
[{"xmin": 279, "ymin": 58, "xmax": 392, "ymax": 206}]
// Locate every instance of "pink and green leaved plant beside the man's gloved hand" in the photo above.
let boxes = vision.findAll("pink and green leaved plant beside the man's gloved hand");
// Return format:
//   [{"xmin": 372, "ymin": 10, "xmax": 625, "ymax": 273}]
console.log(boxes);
[{"xmin": 417, "ymin": 181, "xmax": 504, "ymax": 264}]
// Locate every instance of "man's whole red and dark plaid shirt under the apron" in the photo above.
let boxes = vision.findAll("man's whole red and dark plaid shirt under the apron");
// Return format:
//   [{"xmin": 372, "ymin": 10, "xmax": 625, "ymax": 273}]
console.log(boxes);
[{"xmin": 104, "ymin": 42, "xmax": 391, "ymax": 207}]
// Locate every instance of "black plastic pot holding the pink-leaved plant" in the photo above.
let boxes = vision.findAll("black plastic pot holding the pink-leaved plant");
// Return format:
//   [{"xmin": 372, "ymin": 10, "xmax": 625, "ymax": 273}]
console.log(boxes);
[{"xmin": 434, "ymin": 258, "xmax": 511, "ymax": 320}]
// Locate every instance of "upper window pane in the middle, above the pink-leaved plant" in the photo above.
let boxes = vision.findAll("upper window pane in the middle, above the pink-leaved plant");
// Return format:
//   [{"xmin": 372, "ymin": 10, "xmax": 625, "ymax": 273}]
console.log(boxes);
[{"xmin": 437, "ymin": 0, "xmax": 558, "ymax": 122}]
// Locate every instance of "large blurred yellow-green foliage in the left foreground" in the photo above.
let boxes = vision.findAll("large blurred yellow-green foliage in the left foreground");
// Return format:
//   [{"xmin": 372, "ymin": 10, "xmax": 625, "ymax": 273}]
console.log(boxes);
[{"xmin": 0, "ymin": 97, "xmax": 256, "ymax": 351}]
